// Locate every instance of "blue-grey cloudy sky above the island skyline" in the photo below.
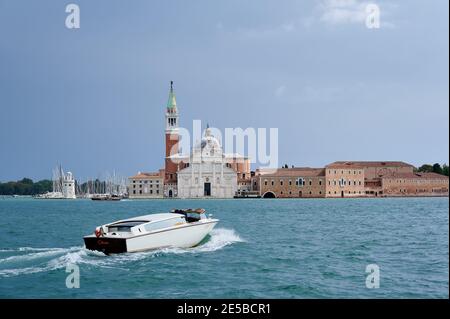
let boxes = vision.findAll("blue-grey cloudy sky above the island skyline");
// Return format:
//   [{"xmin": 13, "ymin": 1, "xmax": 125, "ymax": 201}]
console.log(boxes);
[{"xmin": 0, "ymin": 0, "xmax": 449, "ymax": 181}]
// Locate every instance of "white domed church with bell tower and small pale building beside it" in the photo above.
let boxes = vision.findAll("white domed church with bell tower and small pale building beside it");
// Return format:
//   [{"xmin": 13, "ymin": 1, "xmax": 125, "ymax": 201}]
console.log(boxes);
[{"xmin": 129, "ymin": 82, "xmax": 251, "ymax": 198}]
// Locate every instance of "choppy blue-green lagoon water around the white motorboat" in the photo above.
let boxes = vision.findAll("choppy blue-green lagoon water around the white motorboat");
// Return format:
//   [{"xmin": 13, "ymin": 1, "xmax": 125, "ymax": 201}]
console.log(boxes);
[{"xmin": 0, "ymin": 198, "xmax": 449, "ymax": 298}]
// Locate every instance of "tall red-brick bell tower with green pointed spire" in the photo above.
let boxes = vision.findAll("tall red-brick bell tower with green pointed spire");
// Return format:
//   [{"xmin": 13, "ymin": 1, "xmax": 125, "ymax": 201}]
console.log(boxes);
[{"xmin": 164, "ymin": 81, "xmax": 179, "ymax": 189}]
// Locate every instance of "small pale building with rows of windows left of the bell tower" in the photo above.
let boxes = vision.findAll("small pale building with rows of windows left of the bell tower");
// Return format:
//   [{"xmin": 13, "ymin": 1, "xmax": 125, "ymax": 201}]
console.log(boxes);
[{"xmin": 128, "ymin": 170, "xmax": 164, "ymax": 199}]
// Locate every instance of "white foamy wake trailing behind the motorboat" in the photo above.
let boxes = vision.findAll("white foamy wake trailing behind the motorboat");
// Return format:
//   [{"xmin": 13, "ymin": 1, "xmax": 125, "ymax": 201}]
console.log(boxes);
[{"xmin": 0, "ymin": 228, "xmax": 244, "ymax": 278}]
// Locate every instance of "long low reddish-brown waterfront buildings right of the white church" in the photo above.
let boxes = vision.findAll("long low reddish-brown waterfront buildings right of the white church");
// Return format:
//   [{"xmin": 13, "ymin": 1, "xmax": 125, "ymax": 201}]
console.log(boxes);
[{"xmin": 252, "ymin": 161, "xmax": 449, "ymax": 198}]
